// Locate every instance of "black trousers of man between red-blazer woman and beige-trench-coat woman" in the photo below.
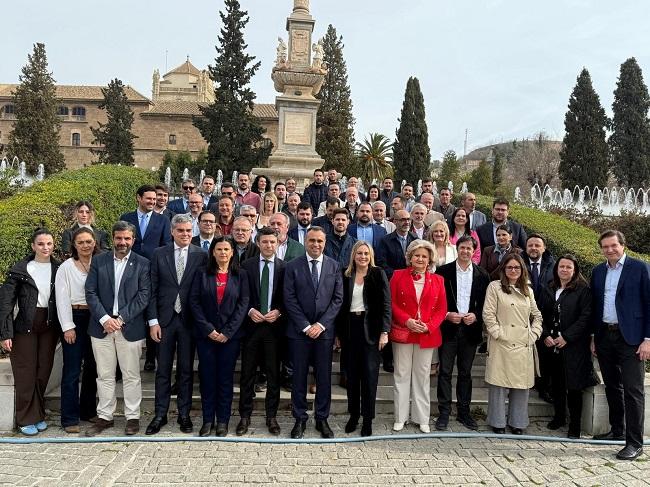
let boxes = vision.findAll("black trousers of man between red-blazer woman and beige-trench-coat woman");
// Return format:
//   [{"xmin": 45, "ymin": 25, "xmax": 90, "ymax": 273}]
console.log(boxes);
[{"xmin": 438, "ymin": 325, "xmax": 476, "ymax": 417}]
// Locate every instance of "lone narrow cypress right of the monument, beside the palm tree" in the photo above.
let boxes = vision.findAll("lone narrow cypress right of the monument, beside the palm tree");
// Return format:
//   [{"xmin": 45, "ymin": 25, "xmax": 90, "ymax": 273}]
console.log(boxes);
[{"xmin": 393, "ymin": 77, "xmax": 431, "ymax": 184}]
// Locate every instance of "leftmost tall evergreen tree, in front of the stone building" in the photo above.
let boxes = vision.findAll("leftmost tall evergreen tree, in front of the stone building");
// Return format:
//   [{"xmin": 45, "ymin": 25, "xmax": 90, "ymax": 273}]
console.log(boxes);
[{"xmin": 7, "ymin": 43, "xmax": 65, "ymax": 175}]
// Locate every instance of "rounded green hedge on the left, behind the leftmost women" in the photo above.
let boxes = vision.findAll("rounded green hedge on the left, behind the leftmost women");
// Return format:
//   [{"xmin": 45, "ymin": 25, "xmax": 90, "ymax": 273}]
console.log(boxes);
[{"xmin": 0, "ymin": 166, "xmax": 157, "ymax": 280}]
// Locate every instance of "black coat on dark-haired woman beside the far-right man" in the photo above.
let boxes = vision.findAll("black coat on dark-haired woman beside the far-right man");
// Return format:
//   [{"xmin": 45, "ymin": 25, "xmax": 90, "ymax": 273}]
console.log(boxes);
[{"xmin": 538, "ymin": 285, "xmax": 593, "ymax": 390}]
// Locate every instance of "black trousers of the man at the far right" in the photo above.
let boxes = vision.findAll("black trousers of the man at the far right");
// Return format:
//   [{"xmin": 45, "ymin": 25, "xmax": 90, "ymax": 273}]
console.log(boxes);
[{"xmin": 595, "ymin": 325, "xmax": 645, "ymax": 448}]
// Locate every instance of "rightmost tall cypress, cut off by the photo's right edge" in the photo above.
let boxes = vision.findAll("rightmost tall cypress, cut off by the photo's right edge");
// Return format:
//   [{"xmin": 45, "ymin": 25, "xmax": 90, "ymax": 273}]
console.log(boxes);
[{"xmin": 609, "ymin": 58, "xmax": 650, "ymax": 187}]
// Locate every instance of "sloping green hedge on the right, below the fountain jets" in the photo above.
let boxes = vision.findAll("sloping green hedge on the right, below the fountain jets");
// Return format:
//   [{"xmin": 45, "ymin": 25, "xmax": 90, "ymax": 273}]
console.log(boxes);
[{"xmin": 476, "ymin": 195, "xmax": 650, "ymax": 276}]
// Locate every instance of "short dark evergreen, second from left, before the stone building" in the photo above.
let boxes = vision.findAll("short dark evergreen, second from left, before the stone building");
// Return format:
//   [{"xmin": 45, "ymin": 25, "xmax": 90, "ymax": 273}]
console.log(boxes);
[{"xmin": 90, "ymin": 78, "xmax": 137, "ymax": 166}]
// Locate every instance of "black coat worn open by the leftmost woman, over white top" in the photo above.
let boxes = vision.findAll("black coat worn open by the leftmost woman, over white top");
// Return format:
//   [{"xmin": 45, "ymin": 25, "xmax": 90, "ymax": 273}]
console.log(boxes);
[{"xmin": 0, "ymin": 254, "xmax": 59, "ymax": 340}]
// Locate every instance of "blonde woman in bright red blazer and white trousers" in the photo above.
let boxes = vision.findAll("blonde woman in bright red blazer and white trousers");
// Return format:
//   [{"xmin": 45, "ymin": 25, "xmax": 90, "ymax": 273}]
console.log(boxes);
[{"xmin": 389, "ymin": 240, "xmax": 447, "ymax": 433}]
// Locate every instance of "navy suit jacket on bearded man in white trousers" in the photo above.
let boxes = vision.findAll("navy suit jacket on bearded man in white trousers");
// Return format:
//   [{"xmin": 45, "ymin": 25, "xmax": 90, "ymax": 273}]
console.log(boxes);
[{"xmin": 86, "ymin": 250, "xmax": 151, "ymax": 342}]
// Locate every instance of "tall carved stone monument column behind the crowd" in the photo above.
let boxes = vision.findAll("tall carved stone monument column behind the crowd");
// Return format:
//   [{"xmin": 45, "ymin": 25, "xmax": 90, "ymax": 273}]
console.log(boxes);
[{"xmin": 252, "ymin": 0, "xmax": 327, "ymax": 188}]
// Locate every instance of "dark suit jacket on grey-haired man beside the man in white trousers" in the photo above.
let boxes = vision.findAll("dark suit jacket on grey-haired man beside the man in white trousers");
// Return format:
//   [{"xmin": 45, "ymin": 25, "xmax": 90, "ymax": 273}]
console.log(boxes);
[{"xmin": 147, "ymin": 243, "xmax": 208, "ymax": 328}]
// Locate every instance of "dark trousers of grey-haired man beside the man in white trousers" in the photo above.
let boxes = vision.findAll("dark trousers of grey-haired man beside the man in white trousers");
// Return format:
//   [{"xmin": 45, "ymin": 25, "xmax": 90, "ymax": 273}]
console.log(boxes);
[{"xmin": 155, "ymin": 313, "xmax": 195, "ymax": 417}]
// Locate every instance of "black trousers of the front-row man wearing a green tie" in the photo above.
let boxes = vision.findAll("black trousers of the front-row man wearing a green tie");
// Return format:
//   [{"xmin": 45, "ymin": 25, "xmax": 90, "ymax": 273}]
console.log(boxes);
[{"xmin": 239, "ymin": 323, "xmax": 280, "ymax": 418}]
